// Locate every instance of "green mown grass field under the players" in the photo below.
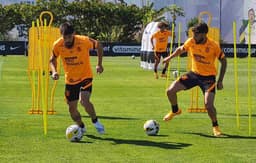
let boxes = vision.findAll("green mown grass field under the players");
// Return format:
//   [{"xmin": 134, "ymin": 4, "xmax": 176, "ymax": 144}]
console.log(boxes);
[{"xmin": 0, "ymin": 56, "xmax": 256, "ymax": 163}]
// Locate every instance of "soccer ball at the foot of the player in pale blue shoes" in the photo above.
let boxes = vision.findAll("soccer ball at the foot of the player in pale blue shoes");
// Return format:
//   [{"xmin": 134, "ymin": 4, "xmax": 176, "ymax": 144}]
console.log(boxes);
[{"xmin": 66, "ymin": 124, "xmax": 83, "ymax": 142}]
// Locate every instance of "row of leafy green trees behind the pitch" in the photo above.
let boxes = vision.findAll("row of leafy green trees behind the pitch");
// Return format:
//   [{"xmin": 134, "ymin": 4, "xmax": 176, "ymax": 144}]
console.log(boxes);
[{"xmin": 0, "ymin": 0, "xmax": 184, "ymax": 43}]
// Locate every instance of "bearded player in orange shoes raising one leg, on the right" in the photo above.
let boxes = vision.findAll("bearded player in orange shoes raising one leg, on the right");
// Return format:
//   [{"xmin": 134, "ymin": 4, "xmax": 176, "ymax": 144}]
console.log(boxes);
[{"xmin": 163, "ymin": 23, "xmax": 227, "ymax": 136}]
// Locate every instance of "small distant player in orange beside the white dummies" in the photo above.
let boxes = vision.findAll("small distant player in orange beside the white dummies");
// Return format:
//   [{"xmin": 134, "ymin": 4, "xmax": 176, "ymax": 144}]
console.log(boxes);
[{"xmin": 150, "ymin": 22, "xmax": 172, "ymax": 79}]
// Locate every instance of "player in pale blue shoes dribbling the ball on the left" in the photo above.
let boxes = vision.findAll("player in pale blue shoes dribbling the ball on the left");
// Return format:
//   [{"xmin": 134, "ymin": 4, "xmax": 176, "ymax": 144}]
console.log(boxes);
[{"xmin": 50, "ymin": 22, "xmax": 105, "ymax": 134}]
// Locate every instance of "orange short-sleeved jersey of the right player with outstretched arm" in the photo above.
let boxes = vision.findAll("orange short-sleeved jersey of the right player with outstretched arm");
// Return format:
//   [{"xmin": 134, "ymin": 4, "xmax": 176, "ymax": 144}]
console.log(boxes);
[{"xmin": 183, "ymin": 38, "xmax": 225, "ymax": 76}]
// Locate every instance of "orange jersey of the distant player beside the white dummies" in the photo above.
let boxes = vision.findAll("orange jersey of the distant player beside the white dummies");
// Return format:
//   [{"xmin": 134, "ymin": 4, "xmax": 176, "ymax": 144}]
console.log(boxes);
[{"xmin": 152, "ymin": 30, "xmax": 172, "ymax": 52}]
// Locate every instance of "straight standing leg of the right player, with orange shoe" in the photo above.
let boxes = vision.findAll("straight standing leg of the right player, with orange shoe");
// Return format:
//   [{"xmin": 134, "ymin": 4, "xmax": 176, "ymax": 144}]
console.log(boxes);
[{"xmin": 204, "ymin": 92, "xmax": 221, "ymax": 136}]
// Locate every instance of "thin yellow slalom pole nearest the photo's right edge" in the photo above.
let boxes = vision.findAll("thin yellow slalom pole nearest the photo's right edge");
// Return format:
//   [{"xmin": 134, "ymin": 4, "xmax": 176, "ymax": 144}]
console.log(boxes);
[{"xmin": 247, "ymin": 23, "xmax": 252, "ymax": 135}]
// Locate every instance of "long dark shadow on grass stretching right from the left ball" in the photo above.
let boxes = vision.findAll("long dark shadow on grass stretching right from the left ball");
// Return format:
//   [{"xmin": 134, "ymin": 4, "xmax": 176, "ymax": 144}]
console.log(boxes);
[{"xmin": 86, "ymin": 135, "xmax": 191, "ymax": 149}]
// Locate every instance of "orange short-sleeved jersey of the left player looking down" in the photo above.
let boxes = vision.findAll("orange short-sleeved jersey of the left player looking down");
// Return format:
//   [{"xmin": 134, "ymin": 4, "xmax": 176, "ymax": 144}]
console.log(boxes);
[{"xmin": 53, "ymin": 35, "xmax": 94, "ymax": 85}]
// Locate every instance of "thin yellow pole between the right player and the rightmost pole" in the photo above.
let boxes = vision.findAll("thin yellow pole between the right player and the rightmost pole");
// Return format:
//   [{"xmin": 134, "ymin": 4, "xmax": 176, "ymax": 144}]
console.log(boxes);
[{"xmin": 233, "ymin": 21, "xmax": 240, "ymax": 128}]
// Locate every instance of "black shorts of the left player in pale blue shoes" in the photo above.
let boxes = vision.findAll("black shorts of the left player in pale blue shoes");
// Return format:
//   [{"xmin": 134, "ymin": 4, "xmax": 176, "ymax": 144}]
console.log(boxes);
[{"xmin": 65, "ymin": 78, "xmax": 92, "ymax": 101}]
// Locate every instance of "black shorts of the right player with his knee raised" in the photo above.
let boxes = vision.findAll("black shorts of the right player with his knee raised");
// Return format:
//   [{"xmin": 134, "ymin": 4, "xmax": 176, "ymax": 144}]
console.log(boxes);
[{"xmin": 179, "ymin": 71, "xmax": 216, "ymax": 93}]
